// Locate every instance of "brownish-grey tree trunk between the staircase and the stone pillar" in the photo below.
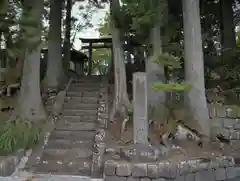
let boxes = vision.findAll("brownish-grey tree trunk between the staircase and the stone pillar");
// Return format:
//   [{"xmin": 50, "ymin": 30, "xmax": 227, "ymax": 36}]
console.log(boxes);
[{"xmin": 110, "ymin": 0, "xmax": 129, "ymax": 119}]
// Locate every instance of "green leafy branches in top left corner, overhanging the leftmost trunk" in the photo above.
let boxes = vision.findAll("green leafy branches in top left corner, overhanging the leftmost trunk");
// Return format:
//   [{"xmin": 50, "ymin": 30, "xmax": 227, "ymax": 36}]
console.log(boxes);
[{"xmin": 0, "ymin": 0, "xmax": 42, "ymax": 59}]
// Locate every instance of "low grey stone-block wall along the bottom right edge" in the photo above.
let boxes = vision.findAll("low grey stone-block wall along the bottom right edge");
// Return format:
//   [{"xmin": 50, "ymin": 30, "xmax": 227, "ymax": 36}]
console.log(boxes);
[{"xmin": 104, "ymin": 157, "xmax": 240, "ymax": 181}]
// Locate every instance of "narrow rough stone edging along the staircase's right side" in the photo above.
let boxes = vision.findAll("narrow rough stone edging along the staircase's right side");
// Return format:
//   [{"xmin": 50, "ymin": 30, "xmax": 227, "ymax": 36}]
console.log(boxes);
[{"xmin": 91, "ymin": 83, "xmax": 108, "ymax": 177}]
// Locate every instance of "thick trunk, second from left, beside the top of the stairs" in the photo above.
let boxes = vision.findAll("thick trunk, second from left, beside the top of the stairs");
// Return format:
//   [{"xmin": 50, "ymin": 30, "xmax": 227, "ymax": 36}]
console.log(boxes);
[{"xmin": 43, "ymin": 0, "xmax": 63, "ymax": 87}]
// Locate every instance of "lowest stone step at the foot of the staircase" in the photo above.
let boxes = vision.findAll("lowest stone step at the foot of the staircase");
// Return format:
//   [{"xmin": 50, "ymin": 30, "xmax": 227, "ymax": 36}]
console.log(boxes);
[{"xmin": 35, "ymin": 159, "xmax": 91, "ymax": 176}]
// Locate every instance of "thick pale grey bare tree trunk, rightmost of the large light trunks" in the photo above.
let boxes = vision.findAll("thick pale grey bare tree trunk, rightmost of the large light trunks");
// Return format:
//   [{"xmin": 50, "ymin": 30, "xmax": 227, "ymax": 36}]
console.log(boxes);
[{"xmin": 182, "ymin": 0, "xmax": 210, "ymax": 136}]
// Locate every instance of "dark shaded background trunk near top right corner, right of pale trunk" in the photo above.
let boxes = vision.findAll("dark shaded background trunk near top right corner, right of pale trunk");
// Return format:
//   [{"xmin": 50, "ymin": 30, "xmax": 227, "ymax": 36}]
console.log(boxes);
[{"xmin": 220, "ymin": 0, "xmax": 236, "ymax": 50}]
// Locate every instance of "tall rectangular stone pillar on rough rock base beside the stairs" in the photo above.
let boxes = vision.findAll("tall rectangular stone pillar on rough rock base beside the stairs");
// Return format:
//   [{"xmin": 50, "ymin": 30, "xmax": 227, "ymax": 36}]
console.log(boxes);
[{"xmin": 121, "ymin": 72, "xmax": 161, "ymax": 162}]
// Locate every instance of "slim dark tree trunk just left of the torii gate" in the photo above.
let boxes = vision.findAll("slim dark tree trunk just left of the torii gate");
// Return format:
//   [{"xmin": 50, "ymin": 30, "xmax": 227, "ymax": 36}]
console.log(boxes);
[{"xmin": 63, "ymin": 0, "xmax": 72, "ymax": 71}]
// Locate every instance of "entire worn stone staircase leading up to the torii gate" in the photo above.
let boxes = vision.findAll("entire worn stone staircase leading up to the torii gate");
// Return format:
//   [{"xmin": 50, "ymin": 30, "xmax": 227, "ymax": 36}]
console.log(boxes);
[{"xmin": 31, "ymin": 77, "xmax": 101, "ymax": 176}]
